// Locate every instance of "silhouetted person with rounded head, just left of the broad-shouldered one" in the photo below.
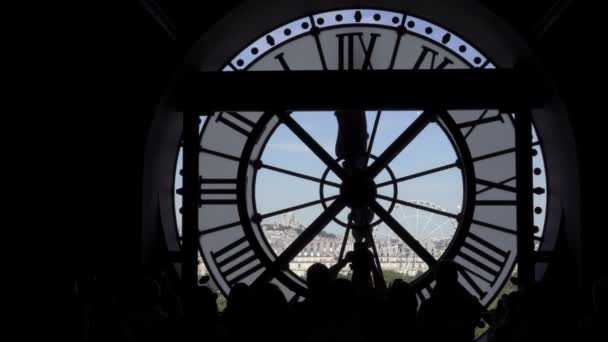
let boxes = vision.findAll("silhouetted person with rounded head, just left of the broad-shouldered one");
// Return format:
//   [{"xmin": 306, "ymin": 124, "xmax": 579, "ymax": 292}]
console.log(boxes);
[{"xmin": 384, "ymin": 279, "xmax": 418, "ymax": 341}]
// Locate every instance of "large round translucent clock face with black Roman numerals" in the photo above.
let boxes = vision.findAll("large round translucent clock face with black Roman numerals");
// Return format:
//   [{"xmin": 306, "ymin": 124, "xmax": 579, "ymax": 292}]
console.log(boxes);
[{"xmin": 175, "ymin": 9, "xmax": 547, "ymax": 305}]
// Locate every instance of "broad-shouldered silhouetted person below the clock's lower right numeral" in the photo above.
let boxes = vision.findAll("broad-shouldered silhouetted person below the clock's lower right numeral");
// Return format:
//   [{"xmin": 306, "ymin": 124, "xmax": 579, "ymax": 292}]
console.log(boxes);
[{"xmin": 418, "ymin": 261, "xmax": 481, "ymax": 342}]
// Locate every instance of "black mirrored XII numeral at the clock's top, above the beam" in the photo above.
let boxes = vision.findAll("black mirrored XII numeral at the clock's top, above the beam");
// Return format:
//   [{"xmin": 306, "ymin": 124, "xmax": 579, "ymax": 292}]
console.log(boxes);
[{"xmin": 336, "ymin": 32, "xmax": 380, "ymax": 70}]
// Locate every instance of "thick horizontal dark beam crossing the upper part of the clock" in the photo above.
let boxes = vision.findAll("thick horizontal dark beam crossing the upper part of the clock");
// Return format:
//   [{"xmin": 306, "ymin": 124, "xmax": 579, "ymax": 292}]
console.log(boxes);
[{"xmin": 178, "ymin": 69, "xmax": 542, "ymax": 112}]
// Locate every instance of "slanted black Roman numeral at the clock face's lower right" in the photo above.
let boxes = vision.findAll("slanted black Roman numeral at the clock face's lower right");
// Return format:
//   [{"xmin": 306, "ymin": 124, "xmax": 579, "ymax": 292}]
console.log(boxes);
[{"xmin": 454, "ymin": 233, "xmax": 511, "ymax": 299}]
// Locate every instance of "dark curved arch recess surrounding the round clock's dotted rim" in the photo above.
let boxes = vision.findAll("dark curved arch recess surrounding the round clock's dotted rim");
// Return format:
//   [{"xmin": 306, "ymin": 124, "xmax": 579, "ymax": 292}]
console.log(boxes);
[{"xmin": 144, "ymin": 0, "xmax": 580, "ymax": 296}]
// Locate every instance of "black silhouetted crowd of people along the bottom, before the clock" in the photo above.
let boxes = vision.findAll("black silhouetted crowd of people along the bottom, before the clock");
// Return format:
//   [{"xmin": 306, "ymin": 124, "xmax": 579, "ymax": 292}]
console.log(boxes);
[{"xmin": 73, "ymin": 248, "xmax": 606, "ymax": 342}]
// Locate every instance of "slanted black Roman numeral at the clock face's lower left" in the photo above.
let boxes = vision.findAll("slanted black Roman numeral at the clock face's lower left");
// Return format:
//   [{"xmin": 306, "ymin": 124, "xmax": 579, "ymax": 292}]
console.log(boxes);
[{"xmin": 211, "ymin": 237, "xmax": 262, "ymax": 287}]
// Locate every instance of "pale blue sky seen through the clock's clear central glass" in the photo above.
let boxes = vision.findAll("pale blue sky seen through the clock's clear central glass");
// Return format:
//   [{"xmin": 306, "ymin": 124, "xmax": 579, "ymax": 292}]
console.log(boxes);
[{"xmin": 176, "ymin": 111, "xmax": 462, "ymax": 239}]
